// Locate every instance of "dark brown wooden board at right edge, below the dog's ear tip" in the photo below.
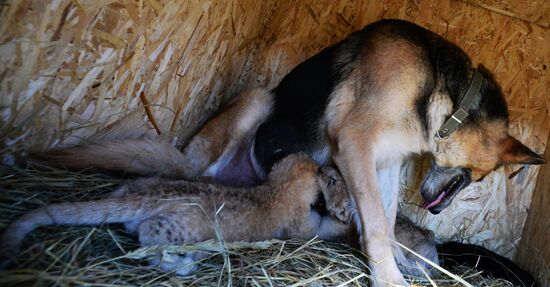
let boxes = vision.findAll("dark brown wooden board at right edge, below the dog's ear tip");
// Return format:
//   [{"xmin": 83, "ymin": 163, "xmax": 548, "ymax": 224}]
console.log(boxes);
[{"xmin": 516, "ymin": 134, "xmax": 550, "ymax": 286}]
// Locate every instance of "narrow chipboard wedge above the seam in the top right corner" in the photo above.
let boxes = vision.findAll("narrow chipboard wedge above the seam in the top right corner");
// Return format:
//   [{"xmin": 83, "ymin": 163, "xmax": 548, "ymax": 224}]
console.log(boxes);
[{"xmin": 466, "ymin": 0, "xmax": 550, "ymax": 28}]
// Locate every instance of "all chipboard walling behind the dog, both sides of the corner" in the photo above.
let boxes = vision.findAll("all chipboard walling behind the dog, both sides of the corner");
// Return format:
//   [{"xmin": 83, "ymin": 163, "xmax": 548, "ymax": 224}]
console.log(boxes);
[{"xmin": 0, "ymin": 0, "xmax": 550, "ymax": 272}]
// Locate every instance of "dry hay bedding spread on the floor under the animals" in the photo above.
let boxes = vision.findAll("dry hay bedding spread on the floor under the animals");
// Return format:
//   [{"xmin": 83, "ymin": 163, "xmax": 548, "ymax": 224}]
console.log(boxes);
[{"xmin": 0, "ymin": 166, "xmax": 512, "ymax": 287}]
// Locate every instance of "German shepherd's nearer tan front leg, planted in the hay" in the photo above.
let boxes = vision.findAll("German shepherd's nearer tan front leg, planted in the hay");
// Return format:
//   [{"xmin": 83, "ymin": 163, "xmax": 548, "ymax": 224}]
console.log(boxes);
[{"xmin": 333, "ymin": 129, "xmax": 408, "ymax": 286}]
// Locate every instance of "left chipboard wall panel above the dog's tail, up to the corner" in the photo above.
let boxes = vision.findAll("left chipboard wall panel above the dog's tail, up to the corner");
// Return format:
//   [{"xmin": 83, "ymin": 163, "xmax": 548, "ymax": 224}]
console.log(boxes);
[{"xmin": 0, "ymin": 0, "xmax": 280, "ymax": 155}]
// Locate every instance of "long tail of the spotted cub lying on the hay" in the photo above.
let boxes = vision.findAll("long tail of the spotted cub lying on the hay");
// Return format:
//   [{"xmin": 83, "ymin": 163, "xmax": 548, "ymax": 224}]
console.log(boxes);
[{"xmin": 0, "ymin": 198, "xmax": 147, "ymax": 267}]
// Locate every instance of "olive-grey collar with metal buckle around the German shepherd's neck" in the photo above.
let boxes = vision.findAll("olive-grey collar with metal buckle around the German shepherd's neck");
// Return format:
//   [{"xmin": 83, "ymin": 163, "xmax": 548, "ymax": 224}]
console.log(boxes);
[{"xmin": 434, "ymin": 69, "xmax": 485, "ymax": 141}]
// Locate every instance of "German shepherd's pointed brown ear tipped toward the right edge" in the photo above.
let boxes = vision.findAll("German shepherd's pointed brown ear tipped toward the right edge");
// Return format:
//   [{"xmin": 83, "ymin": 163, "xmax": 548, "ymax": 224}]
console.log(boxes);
[{"xmin": 499, "ymin": 136, "xmax": 546, "ymax": 164}]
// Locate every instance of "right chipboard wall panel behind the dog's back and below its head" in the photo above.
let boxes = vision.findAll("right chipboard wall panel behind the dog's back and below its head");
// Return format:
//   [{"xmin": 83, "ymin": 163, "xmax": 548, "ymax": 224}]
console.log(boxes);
[{"xmin": 251, "ymin": 0, "xmax": 550, "ymax": 257}]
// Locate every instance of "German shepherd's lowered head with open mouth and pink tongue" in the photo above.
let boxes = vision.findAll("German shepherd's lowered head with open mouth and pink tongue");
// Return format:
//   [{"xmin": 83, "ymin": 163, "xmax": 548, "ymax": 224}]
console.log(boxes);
[{"xmin": 421, "ymin": 68, "xmax": 545, "ymax": 214}]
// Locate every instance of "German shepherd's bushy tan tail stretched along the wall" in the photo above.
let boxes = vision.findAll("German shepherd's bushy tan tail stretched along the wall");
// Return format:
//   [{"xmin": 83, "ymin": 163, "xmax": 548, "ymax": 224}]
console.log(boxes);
[{"xmin": 30, "ymin": 140, "xmax": 190, "ymax": 179}]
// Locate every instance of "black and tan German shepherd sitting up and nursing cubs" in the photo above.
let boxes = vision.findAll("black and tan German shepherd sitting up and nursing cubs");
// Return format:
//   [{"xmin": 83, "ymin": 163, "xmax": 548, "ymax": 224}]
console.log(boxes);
[{"xmin": 36, "ymin": 20, "xmax": 544, "ymax": 286}]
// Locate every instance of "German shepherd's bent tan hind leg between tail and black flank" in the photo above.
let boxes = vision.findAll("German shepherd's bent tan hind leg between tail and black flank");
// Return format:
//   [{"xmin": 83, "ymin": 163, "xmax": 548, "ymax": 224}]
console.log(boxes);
[{"xmin": 182, "ymin": 89, "xmax": 273, "ymax": 181}]
